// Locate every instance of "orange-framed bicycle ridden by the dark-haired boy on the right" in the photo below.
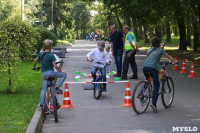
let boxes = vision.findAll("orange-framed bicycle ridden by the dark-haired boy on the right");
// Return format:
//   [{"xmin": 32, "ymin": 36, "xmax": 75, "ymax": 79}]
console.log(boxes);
[{"xmin": 132, "ymin": 62, "xmax": 174, "ymax": 114}]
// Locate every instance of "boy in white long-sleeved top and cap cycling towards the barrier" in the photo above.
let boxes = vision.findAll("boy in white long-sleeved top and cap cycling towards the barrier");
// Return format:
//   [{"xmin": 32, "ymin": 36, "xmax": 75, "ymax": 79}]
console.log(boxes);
[{"xmin": 87, "ymin": 41, "xmax": 109, "ymax": 92}]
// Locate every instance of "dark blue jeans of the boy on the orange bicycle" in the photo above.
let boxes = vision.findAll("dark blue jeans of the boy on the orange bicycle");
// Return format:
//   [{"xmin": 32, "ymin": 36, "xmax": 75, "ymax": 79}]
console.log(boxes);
[{"xmin": 143, "ymin": 67, "xmax": 160, "ymax": 105}]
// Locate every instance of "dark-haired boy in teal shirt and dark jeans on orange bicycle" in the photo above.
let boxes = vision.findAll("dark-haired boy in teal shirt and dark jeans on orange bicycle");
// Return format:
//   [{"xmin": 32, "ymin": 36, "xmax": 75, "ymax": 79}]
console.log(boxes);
[{"xmin": 143, "ymin": 37, "xmax": 174, "ymax": 112}]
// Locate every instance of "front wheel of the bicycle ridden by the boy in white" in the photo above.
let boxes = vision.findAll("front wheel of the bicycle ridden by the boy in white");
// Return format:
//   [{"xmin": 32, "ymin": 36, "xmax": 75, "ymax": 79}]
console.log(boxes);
[{"xmin": 94, "ymin": 79, "xmax": 103, "ymax": 100}]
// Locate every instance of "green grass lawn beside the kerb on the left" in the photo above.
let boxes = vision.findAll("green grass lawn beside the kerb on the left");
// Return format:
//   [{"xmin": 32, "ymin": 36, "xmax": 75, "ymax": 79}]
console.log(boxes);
[{"xmin": 0, "ymin": 63, "xmax": 42, "ymax": 133}]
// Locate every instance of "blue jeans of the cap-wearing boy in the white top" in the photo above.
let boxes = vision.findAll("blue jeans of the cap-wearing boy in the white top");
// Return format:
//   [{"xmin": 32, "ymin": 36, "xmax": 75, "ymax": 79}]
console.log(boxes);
[{"xmin": 91, "ymin": 66, "xmax": 106, "ymax": 90}]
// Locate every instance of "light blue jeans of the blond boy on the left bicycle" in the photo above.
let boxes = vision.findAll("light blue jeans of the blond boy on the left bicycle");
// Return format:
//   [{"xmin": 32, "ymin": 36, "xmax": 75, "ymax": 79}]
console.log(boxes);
[{"xmin": 40, "ymin": 70, "xmax": 67, "ymax": 105}]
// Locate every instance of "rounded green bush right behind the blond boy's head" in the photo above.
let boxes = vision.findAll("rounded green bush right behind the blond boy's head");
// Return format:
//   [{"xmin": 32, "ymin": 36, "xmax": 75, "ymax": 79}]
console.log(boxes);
[{"xmin": 35, "ymin": 28, "xmax": 58, "ymax": 52}]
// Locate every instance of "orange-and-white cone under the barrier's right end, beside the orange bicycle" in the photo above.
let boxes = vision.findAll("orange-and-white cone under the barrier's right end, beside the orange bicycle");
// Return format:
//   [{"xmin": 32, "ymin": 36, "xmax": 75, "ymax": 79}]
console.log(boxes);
[{"xmin": 121, "ymin": 82, "xmax": 133, "ymax": 107}]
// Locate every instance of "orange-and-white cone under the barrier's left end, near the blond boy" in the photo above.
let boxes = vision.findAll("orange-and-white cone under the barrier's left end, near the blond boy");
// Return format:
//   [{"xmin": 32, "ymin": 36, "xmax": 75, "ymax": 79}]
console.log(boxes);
[{"xmin": 60, "ymin": 83, "xmax": 74, "ymax": 109}]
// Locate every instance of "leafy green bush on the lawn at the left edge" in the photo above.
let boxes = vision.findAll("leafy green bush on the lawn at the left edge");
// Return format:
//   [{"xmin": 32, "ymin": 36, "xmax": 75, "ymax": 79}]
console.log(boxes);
[{"xmin": 0, "ymin": 18, "xmax": 37, "ymax": 92}]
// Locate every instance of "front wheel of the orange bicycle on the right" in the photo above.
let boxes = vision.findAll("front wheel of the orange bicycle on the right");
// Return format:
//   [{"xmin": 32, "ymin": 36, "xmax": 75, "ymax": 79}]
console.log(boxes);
[{"xmin": 161, "ymin": 77, "xmax": 174, "ymax": 108}]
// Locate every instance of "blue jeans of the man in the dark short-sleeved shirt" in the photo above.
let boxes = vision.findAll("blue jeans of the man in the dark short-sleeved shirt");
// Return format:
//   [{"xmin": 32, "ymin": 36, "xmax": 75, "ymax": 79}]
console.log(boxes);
[{"xmin": 113, "ymin": 49, "xmax": 123, "ymax": 75}]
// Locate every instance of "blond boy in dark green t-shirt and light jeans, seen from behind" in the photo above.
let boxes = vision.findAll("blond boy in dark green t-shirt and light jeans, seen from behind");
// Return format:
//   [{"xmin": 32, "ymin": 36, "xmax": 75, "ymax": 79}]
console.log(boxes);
[{"xmin": 33, "ymin": 39, "xmax": 66, "ymax": 110}]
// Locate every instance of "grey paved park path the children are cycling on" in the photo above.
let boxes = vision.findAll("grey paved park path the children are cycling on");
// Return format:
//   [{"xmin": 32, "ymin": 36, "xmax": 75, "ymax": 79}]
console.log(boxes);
[{"xmin": 42, "ymin": 40, "xmax": 200, "ymax": 133}]
